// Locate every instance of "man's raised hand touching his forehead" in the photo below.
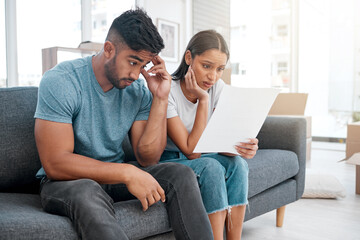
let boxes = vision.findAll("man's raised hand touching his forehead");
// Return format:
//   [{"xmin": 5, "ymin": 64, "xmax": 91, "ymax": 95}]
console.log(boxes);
[{"xmin": 141, "ymin": 56, "xmax": 171, "ymax": 99}]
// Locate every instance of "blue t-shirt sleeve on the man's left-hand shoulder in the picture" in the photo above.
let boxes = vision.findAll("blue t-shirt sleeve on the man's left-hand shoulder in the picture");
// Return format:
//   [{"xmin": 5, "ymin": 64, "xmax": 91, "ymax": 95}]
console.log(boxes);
[{"xmin": 35, "ymin": 71, "xmax": 80, "ymax": 123}]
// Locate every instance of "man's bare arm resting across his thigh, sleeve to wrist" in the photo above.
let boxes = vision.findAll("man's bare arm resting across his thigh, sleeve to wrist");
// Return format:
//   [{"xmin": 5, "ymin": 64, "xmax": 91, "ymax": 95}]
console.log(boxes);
[{"xmin": 34, "ymin": 119, "xmax": 135, "ymax": 184}]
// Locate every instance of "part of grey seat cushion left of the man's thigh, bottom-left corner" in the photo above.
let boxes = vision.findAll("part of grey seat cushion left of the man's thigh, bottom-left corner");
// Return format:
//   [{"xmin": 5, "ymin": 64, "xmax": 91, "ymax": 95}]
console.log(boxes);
[{"xmin": 0, "ymin": 193, "xmax": 78, "ymax": 240}]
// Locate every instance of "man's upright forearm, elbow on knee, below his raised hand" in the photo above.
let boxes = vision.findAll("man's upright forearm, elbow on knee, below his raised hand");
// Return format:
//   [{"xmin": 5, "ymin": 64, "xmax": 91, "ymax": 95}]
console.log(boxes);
[{"xmin": 137, "ymin": 97, "xmax": 168, "ymax": 166}]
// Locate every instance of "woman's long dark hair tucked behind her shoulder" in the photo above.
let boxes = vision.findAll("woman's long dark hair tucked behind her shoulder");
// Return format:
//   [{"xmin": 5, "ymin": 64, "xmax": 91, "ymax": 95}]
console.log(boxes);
[{"xmin": 172, "ymin": 30, "xmax": 230, "ymax": 80}]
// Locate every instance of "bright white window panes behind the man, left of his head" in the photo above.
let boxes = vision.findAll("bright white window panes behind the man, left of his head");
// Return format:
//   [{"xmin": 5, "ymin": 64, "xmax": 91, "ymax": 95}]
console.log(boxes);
[{"xmin": 13, "ymin": 0, "xmax": 135, "ymax": 86}]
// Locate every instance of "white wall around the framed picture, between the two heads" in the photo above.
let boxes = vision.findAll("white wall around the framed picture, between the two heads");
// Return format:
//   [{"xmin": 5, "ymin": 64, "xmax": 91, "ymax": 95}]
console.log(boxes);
[{"xmin": 137, "ymin": 0, "xmax": 192, "ymax": 74}]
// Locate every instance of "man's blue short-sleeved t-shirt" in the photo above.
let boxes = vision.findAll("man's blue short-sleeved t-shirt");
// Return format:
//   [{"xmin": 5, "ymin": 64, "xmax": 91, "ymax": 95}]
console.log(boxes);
[{"xmin": 35, "ymin": 56, "xmax": 152, "ymax": 178}]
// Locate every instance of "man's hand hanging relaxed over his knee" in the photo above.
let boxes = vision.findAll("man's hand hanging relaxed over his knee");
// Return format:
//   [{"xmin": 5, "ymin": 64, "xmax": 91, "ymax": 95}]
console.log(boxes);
[{"xmin": 125, "ymin": 166, "xmax": 166, "ymax": 211}]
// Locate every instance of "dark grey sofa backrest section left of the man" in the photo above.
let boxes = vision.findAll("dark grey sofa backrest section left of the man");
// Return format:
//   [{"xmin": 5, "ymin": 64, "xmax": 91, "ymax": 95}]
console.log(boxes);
[{"xmin": 0, "ymin": 87, "xmax": 41, "ymax": 193}]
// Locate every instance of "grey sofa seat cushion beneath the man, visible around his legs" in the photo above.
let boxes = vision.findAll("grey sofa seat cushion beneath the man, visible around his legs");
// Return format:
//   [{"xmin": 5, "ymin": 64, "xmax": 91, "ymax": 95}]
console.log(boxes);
[{"xmin": 0, "ymin": 193, "xmax": 171, "ymax": 240}]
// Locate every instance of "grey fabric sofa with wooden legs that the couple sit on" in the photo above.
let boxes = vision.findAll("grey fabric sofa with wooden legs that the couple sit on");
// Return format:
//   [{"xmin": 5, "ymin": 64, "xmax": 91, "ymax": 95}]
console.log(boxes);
[{"xmin": 0, "ymin": 87, "xmax": 306, "ymax": 240}]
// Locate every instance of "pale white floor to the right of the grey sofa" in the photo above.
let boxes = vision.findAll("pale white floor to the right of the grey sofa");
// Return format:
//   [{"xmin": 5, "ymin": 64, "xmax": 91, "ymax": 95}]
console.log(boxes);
[{"xmin": 242, "ymin": 142, "xmax": 360, "ymax": 240}]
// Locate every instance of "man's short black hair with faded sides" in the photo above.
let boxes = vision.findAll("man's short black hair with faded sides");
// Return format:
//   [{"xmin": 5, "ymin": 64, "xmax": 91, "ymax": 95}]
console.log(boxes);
[{"xmin": 106, "ymin": 8, "xmax": 164, "ymax": 54}]
